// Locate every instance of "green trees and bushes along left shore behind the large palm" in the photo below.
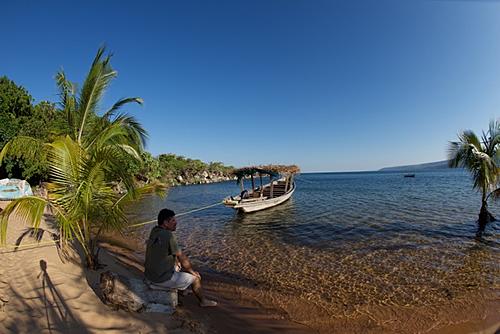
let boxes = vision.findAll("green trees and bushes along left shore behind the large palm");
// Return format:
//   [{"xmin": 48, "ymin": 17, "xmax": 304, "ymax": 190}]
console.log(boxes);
[{"xmin": 0, "ymin": 75, "xmax": 233, "ymax": 187}]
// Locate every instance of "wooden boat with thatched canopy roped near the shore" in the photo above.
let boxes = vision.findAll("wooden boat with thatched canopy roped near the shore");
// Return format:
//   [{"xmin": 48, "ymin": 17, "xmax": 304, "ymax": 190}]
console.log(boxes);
[{"xmin": 224, "ymin": 165, "xmax": 300, "ymax": 212}]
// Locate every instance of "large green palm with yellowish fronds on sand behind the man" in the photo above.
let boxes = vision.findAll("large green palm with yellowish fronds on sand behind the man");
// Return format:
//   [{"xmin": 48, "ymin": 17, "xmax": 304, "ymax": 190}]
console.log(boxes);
[{"xmin": 0, "ymin": 48, "xmax": 163, "ymax": 269}]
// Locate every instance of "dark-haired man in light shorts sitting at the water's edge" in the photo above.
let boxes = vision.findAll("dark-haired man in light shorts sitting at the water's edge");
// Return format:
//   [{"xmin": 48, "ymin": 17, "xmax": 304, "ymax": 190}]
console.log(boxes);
[{"xmin": 144, "ymin": 209, "xmax": 217, "ymax": 307}]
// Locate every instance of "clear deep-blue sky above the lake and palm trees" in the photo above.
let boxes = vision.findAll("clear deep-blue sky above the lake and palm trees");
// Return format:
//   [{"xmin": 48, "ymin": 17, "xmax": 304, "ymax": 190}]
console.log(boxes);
[{"xmin": 0, "ymin": 0, "xmax": 500, "ymax": 171}]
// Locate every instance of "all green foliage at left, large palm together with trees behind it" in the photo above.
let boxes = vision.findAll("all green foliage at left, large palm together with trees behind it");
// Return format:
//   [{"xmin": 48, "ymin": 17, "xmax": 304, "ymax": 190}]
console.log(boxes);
[{"xmin": 0, "ymin": 48, "xmax": 234, "ymax": 268}]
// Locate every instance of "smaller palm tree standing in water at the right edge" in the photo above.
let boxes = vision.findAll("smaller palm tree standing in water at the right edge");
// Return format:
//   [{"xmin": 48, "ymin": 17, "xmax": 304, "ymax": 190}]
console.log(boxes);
[{"xmin": 448, "ymin": 120, "xmax": 500, "ymax": 226}]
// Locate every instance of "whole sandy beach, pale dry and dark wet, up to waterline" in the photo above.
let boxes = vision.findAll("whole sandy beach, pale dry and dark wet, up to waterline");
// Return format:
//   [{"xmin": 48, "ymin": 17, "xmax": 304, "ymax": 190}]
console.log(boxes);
[{"xmin": 0, "ymin": 202, "xmax": 311, "ymax": 333}]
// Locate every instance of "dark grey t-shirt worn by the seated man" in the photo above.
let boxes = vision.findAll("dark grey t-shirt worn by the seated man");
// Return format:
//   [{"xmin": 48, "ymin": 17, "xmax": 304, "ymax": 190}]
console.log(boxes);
[{"xmin": 144, "ymin": 226, "xmax": 179, "ymax": 283}]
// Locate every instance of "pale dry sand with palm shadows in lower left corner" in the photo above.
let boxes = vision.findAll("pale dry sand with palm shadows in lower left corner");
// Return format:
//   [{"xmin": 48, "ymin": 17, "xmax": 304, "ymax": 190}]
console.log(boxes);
[{"xmin": 0, "ymin": 202, "xmax": 187, "ymax": 333}]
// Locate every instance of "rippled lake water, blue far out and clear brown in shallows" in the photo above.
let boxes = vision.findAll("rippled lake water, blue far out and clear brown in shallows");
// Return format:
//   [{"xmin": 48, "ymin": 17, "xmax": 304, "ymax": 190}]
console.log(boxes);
[{"xmin": 126, "ymin": 170, "xmax": 500, "ymax": 332}]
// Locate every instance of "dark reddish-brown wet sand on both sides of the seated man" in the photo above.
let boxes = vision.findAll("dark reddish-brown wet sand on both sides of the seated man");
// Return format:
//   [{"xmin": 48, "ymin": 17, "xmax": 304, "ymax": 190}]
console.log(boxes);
[{"xmin": 102, "ymin": 243, "xmax": 317, "ymax": 334}]
